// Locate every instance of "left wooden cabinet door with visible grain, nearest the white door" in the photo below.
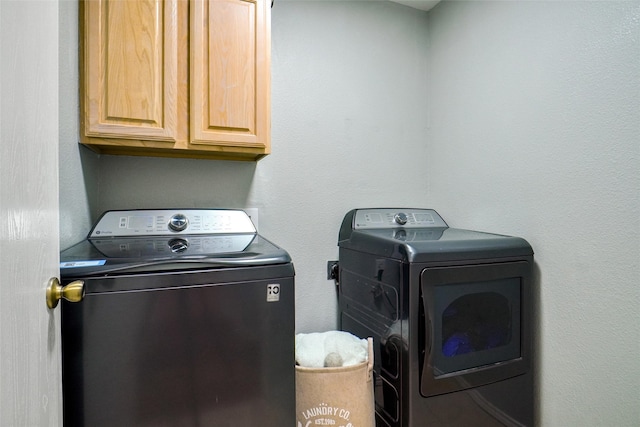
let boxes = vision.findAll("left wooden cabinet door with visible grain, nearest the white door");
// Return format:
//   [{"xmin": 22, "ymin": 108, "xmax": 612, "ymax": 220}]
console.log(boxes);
[{"xmin": 82, "ymin": 0, "xmax": 181, "ymax": 145}]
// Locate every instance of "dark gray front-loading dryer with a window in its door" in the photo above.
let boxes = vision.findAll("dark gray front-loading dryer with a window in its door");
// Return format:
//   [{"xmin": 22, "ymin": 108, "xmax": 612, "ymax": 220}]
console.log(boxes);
[{"xmin": 338, "ymin": 208, "xmax": 534, "ymax": 427}]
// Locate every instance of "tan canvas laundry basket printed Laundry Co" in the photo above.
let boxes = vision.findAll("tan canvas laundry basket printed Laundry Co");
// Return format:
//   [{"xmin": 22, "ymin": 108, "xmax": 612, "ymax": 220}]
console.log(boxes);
[{"xmin": 296, "ymin": 338, "xmax": 375, "ymax": 427}]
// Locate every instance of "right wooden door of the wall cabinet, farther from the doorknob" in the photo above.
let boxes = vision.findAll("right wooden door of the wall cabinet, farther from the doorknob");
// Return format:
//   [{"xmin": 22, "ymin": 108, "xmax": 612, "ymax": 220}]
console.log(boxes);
[{"xmin": 190, "ymin": 0, "xmax": 271, "ymax": 154}]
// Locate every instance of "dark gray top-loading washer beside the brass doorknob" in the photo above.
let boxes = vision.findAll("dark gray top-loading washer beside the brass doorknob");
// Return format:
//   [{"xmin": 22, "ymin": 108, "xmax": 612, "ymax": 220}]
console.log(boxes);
[{"xmin": 61, "ymin": 209, "xmax": 295, "ymax": 427}]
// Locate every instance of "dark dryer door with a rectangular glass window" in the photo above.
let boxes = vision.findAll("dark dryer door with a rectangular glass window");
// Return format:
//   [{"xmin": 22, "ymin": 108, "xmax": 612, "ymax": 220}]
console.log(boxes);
[{"xmin": 420, "ymin": 261, "xmax": 531, "ymax": 396}]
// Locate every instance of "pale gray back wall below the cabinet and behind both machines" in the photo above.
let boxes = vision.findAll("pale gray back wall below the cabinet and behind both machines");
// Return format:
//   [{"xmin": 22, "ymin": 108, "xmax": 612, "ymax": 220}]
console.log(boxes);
[{"xmin": 60, "ymin": 0, "xmax": 427, "ymax": 332}]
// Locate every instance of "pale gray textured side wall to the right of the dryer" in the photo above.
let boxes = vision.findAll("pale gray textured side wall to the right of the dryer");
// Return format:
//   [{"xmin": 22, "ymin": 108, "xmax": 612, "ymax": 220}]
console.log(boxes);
[{"xmin": 427, "ymin": 1, "xmax": 640, "ymax": 427}]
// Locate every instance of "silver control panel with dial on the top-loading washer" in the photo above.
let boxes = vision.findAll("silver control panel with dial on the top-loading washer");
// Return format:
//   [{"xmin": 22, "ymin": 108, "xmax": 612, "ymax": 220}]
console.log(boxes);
[{"xmin": 89, "ymin": 209, "xmax": 256, "ymax": 238}]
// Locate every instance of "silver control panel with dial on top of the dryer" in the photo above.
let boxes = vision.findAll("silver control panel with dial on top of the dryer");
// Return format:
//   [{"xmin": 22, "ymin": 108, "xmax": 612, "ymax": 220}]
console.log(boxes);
[{"xmin": 353, "ymin": 208, "xmax": 447, "ymax": 229}]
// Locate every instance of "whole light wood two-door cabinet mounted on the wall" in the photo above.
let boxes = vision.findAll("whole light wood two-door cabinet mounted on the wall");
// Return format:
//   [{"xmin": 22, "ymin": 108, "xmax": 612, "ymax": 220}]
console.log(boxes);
[{"xmin": 81, "ymin": 0, "xmax": 271, "ymax": 160}]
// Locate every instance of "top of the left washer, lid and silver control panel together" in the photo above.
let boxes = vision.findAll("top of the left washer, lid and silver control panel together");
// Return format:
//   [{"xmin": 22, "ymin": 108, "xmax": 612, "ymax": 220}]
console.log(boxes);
[{"xmin": 60, "ymin": 209, "xmax": 291, "ymax": 278}]
